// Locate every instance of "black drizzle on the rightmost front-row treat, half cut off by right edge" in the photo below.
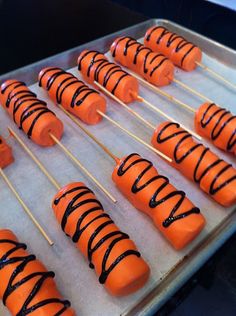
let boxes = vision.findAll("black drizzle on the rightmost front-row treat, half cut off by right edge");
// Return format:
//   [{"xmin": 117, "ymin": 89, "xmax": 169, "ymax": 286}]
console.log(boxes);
[{"xmin": 201, "ymin": 103, "xmax": 236, "ymax": 151}]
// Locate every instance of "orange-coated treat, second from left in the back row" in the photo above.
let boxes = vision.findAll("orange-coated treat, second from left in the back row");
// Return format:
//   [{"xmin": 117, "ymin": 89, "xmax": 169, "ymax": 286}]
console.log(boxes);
[{"xmin": 39, "ymin": 67, "xmax": 106, "ymax": 125}]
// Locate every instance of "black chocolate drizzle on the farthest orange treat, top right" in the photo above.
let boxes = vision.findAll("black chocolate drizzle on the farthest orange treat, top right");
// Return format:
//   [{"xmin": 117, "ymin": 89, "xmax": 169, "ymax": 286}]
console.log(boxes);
[{"xmin": 145, "ymin": 26, "xmax": 197, "ymax": 66}]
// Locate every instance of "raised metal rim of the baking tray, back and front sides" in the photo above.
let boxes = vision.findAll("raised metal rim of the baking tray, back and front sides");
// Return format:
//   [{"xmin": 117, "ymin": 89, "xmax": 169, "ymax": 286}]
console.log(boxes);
[{"xmin": 0, "ymin": 18, "xmax": 236, "ymax": 316}]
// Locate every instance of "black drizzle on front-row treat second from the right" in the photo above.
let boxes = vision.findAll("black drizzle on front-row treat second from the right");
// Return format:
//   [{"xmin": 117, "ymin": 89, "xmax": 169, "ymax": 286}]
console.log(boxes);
[{"xmin": 156, "ymin": 123, "xmax": 236, "ymax": 195}]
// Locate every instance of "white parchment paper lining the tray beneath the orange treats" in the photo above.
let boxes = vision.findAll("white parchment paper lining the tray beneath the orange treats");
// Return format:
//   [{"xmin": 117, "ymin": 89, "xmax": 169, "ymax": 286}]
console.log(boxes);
[{"xmin": 0, "ymin": 35, "xmax": 236, "ymax": 316}]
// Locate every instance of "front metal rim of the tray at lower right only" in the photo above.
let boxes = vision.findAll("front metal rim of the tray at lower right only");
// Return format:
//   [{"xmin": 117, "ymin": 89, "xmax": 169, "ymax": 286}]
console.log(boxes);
[{"xmin": 124, "ymin": 209, "xmax": 236, "ymax": 316}]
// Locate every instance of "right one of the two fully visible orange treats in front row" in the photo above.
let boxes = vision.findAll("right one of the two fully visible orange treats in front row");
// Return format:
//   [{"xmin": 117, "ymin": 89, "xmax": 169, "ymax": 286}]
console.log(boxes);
[{"xmin": 112, "ymin": 154, "xmax": 205, "ymax": 250}]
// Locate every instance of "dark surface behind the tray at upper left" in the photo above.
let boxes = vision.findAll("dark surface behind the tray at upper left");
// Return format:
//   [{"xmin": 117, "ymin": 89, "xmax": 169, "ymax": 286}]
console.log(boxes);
[{"xmin": 0, "ymin": 0, "xmax": 147, "ymax": 74}]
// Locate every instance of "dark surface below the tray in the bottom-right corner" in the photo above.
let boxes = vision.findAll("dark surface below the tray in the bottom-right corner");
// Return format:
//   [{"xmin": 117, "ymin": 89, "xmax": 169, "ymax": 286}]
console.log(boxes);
[{"xmin": 159, "ymin": 234, "xmax": 236, "ymax": 316}]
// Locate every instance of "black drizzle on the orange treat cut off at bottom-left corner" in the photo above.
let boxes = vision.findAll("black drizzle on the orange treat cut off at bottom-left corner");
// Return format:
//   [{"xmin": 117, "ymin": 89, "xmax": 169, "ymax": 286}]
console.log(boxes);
[{"xmin": 0, "ymin": 239, "xmax": 70, "ymax": 316}]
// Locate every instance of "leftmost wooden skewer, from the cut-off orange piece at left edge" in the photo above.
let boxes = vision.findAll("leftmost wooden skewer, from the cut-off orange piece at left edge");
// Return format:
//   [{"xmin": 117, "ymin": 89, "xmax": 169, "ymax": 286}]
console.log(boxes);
[{"xmin": 0, "ymin": 168, "xmax": 54, "ymax": 246}]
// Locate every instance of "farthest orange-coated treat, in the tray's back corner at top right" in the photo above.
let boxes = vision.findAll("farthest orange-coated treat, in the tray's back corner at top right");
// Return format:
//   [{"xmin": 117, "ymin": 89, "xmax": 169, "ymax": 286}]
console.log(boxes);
[{"xmin": 144, "ymin": 26, "xmax": 202, "ymax": 71}]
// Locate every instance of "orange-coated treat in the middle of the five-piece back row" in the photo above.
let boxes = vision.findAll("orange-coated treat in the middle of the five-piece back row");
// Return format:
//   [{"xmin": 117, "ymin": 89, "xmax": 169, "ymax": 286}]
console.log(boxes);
[{"xmin": 77, "ymin": 50, "xmax": 139, "ymax": 103}]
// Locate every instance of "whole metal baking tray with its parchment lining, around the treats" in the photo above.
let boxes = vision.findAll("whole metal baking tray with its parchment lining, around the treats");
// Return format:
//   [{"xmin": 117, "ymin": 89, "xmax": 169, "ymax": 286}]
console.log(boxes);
[{"xmin": 0, "ymin": 19, "xmax": 236, "ymax": 316}]
